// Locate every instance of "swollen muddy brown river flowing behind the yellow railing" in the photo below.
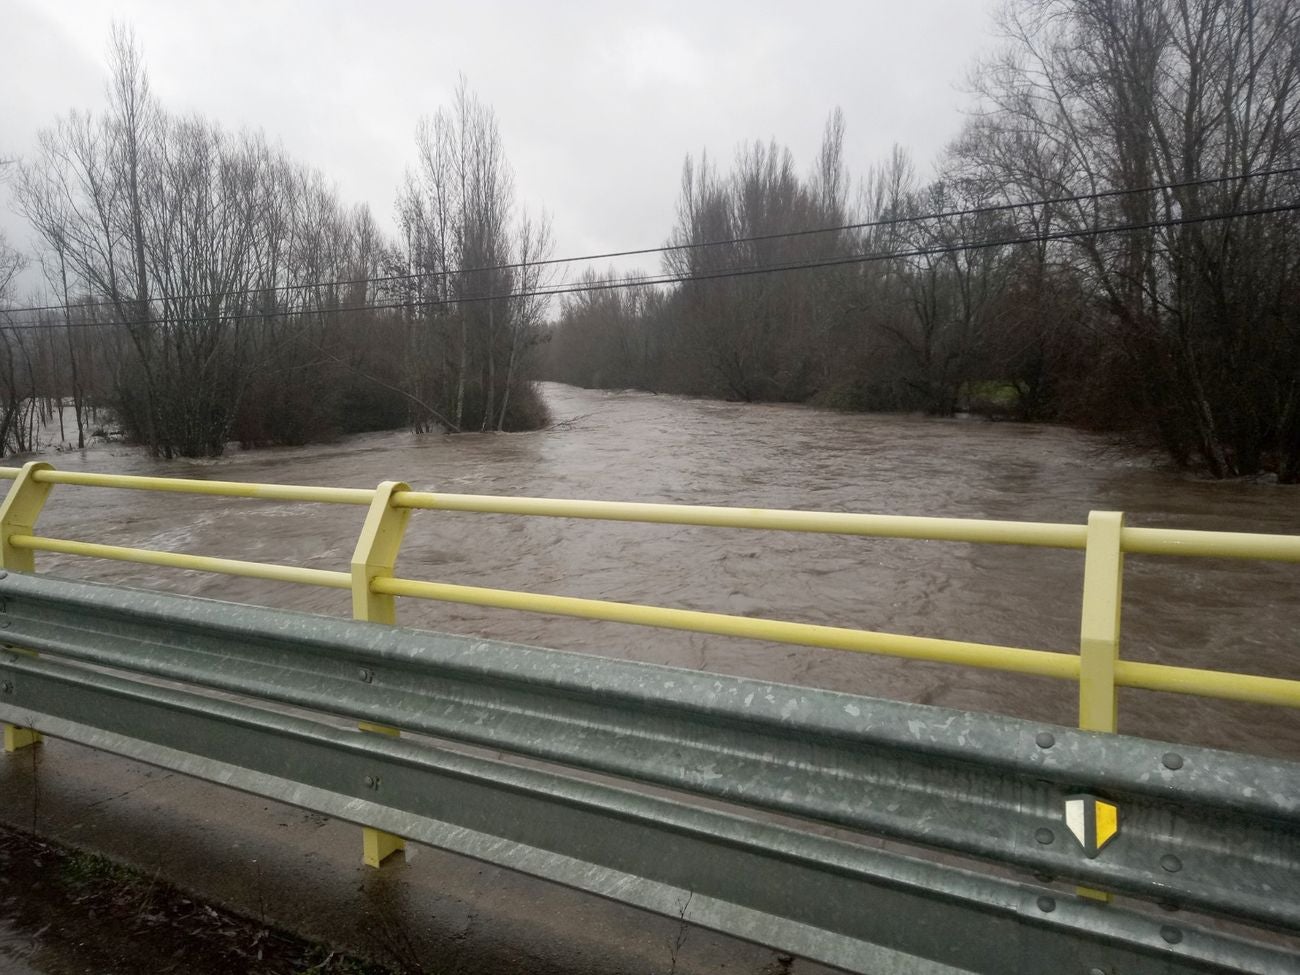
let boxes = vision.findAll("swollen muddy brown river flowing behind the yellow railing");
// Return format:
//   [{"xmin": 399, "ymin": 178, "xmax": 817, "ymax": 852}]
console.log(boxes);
[{"xmin": 10, "ymin": 385, "xmax": 1300, "ymax": 759}]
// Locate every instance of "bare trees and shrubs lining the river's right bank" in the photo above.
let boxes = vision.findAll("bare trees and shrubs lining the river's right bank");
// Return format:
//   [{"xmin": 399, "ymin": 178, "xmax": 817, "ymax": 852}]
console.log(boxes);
[{"xmin": 546, "ymin": 0, "xmax": 1300, "ymax": 482}]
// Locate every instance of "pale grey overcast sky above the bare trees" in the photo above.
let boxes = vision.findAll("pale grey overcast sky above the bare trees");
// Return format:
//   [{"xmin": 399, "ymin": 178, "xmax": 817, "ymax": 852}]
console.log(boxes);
[{"xmin": 0, "ymin": 0, "xmax": 995, "ymax": 297}]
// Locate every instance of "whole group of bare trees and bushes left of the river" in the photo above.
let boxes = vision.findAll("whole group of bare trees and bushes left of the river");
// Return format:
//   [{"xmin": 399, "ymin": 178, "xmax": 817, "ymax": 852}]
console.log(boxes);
[{"xmin": 0, "ymin": 27, "xmax": 550, "ymax": 458}]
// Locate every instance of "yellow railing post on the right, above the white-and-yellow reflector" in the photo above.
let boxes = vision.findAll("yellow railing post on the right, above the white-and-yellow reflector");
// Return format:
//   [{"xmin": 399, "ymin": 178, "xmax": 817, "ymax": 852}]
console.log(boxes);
[{"xmin": 1075, "ymin": 511, "xmax": 1125, "ymax": 901}]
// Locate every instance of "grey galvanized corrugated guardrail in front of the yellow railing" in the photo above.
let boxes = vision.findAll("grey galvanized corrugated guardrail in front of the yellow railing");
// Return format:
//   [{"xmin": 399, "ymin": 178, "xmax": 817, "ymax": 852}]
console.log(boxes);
[{"xmin": 0, "ymin": 572, "xmax": 1300, "ymax": 975}]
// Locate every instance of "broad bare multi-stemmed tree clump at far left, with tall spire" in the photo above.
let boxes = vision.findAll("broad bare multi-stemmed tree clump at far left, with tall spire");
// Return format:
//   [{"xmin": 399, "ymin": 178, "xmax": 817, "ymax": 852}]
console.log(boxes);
[{"xmin": 18, "ymin": 22, "xmax": 404, "ymax": 458}]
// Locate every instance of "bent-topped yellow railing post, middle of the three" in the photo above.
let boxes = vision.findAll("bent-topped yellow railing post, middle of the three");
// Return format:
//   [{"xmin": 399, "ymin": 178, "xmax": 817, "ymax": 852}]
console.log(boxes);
[{"xmin": 352, "ymin": 481, "xmax": 411, "ymax": 867}]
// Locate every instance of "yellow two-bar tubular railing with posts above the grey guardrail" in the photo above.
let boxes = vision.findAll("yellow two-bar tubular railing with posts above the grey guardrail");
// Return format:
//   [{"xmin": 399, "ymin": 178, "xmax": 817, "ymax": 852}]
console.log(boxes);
[{"xmin": 0, "ymin": 463, "xmax": 1300, "ymax": 731}]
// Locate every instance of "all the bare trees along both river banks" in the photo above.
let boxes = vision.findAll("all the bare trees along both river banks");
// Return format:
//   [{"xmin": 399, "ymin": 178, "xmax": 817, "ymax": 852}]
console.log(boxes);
[{"xmin": 0, "ymin": 0, "xmax": 1300, "ymax": 482}]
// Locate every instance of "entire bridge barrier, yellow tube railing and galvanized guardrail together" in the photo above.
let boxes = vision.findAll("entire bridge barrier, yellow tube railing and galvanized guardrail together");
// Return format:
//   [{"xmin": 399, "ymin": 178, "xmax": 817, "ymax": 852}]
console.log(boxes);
[{"xmin": 0, "ymin": 463, "xmax": 1300, "ymax": 972}]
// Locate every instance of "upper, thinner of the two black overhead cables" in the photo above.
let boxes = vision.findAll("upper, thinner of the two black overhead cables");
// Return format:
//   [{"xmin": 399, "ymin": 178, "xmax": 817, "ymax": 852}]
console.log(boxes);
[{"xmin": 8, "ymin": 166, "xmax": 1300, "ymax": 324}]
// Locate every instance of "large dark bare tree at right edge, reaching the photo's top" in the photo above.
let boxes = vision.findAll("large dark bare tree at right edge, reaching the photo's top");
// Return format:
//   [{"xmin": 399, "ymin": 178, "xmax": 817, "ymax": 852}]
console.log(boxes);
[{"xmin": 963, "ymin": 0, "xmax": 1300, "ymax": 481}]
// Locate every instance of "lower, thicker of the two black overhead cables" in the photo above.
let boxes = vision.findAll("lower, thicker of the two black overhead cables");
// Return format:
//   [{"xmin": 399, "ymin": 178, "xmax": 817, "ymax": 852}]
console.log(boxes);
[{"xmin": 0, "ymin": 203, "xmax": 1300, "ymax": 332}]
